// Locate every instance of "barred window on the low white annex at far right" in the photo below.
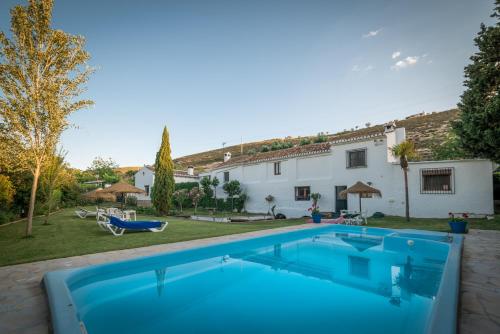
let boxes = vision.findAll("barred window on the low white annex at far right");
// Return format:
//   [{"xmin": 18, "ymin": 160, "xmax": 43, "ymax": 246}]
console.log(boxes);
[{"xmin": 420, "ymin": 168, "xmax": 455, "ymax": 194}]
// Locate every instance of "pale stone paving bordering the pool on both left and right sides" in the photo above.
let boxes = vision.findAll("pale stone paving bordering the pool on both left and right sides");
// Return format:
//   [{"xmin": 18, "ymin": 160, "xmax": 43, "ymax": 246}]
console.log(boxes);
[{"xmin": 0, "ymin": 224, "xmax": 500, "ymax": 334}]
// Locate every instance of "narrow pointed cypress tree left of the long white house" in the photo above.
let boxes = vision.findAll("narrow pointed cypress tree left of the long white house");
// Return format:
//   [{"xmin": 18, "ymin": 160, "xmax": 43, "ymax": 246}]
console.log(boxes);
[{"xmin": 151, "ymin": 127, "xmax": 175, "ymax": 215}]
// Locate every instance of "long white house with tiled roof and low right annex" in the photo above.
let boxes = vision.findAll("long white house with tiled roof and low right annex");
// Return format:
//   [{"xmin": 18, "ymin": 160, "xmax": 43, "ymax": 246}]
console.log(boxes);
[{"xmin": 200, "ymin": 123, "xmax": 494, "ymax": 218}]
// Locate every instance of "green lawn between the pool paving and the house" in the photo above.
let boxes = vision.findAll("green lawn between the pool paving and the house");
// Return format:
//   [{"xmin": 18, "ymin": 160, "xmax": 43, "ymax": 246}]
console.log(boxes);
[{"xmin": 0, "ymin": 209, "xmax": 500, "ymax": 266}]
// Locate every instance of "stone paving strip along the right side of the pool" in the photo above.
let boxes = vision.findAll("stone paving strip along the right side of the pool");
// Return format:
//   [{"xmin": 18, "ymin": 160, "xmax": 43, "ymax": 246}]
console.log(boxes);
[{"xmin": 459, "ymin": 230, "xmax": 500, "ymax": 334}]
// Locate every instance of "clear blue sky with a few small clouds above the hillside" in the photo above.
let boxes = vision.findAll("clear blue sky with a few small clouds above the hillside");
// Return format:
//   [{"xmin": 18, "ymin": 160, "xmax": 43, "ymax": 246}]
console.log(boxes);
[{"xmin": 0, "ymin": 0, "xmax": 493, "ymax": 168}]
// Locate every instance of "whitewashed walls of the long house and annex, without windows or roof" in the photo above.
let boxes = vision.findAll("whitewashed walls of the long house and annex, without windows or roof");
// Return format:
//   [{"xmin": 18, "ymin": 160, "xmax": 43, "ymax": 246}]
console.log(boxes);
[{"xmin": 201, "ymin": 138, "xmax": 493, "ymax": 218}]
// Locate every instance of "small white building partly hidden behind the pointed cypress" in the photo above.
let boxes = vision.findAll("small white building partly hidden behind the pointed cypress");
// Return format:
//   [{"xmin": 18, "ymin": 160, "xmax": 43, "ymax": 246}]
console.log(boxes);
[{"xmin": 134, "ymin": 165, "xmax": 199, "ymax": 204}]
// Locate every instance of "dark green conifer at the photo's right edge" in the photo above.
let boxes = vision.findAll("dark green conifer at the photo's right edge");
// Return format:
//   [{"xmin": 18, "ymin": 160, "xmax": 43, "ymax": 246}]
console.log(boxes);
[{"xmin": 453, "ymin": 0, "xmax": 500, "ymax": 163}]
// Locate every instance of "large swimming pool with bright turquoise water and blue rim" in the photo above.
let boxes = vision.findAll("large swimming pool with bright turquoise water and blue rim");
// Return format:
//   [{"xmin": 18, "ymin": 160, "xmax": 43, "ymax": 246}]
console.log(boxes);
[{"xmin": 44, "ymin": 226, "xmax": 463, "ymax": 334}]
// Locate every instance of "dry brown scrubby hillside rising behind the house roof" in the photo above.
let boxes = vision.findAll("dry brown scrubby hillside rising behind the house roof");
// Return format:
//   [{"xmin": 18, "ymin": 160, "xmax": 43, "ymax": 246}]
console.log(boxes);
[{"xmin": 174, "ymin": 109, "xmax": 458, "ymax": 172}]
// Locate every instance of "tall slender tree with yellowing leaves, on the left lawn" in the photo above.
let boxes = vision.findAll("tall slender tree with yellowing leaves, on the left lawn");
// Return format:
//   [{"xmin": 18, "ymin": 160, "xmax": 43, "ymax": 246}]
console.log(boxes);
[{"xmin": 0, "ymin": 0, "xmax": 93, "ymax": 236}]
